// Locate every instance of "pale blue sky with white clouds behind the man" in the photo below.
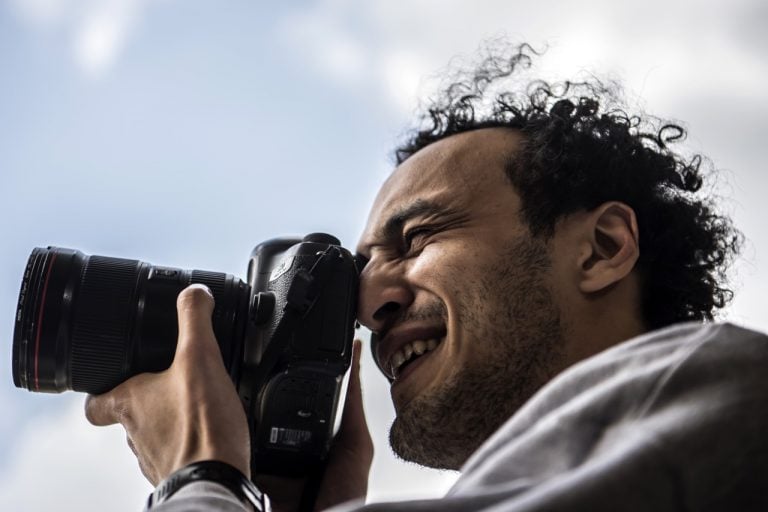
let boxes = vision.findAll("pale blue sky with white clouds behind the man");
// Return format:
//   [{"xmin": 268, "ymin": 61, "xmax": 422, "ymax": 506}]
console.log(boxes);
[{"xmin": 0, "ymin": 0, "xmax": 768, "ymax": 511}]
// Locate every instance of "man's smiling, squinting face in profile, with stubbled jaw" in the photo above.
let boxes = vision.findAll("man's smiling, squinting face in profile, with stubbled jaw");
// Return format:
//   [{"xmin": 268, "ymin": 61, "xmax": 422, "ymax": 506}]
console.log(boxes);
[{"xmin": 358, "ymin": 128, "xmax": 563, "ymax": 469}]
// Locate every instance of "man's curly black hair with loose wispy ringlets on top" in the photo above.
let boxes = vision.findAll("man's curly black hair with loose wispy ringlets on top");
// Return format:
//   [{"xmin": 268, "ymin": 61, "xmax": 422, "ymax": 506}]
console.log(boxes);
[{"xmin": 395, "ymin": 44, "xmax": 742, "ymax": 329}]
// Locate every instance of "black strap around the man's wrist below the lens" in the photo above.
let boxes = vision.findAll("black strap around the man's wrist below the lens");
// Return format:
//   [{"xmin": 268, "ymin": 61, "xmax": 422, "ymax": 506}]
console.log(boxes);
[{"xmin": 147, "ymin": 460, "xmax": 269, "ymax": 512}]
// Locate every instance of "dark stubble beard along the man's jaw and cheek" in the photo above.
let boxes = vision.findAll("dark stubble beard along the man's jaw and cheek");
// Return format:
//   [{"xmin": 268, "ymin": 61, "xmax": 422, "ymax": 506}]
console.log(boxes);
[{"xmin": 389, "ymin": 238, "xmax": 563, "ymax": 470}]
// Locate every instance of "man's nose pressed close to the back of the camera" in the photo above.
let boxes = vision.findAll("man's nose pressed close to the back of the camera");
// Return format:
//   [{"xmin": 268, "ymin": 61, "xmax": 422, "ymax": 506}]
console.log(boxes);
[{"xmin": 357, "ymin": 261, "xmax": 413, "ymax": 332}]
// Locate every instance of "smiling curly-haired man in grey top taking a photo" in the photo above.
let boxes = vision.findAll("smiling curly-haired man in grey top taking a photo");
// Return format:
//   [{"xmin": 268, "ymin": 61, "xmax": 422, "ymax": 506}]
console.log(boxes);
[{"xmin": 86, "ymin": 46, "xmax": 768, "ymax": 511}]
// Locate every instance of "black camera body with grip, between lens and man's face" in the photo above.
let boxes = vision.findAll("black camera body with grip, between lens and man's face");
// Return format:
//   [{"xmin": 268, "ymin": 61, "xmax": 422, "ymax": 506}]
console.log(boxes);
[{"xmin": 242, "ymin": 234, "xmax": 358, "ymax": 475}]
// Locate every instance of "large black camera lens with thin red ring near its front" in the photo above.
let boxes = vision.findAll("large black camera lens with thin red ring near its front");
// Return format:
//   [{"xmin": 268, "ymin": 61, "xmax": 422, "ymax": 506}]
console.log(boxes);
[{"xmin": 13, "ymin": 247, "xmax": 249, "ymax": 394}]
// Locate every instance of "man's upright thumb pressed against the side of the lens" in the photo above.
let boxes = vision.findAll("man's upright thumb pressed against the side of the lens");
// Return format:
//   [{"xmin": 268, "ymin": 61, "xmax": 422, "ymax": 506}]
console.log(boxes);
[{"xmin": 176, "ymin": 283, "xmax": 219, "ymax": 355}]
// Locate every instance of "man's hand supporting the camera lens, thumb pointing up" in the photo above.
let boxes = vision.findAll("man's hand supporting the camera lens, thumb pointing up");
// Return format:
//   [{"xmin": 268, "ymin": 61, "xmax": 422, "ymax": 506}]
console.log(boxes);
[{"xmin": 85, "ymin": 285, "xmax": 251, "ymax": 485}]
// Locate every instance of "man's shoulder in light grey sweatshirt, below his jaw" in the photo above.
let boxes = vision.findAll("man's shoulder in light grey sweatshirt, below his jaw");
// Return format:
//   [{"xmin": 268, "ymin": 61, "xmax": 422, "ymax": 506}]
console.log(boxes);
[{"xmin": 457, "ymin": 323, "xmax": 768, "ymax": 509}]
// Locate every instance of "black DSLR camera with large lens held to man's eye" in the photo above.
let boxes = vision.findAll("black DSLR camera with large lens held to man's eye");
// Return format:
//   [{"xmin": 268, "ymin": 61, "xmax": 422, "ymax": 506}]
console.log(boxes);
[{"xmin": 13, "ymin": 233, "xmax": 358, "ymax": 475}]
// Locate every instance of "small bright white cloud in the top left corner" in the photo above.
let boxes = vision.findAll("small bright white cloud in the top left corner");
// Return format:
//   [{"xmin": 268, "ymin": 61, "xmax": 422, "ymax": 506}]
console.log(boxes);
[{"xmin": 11, "ymin": 0, "xmax": 157, "ymax": 78}]
